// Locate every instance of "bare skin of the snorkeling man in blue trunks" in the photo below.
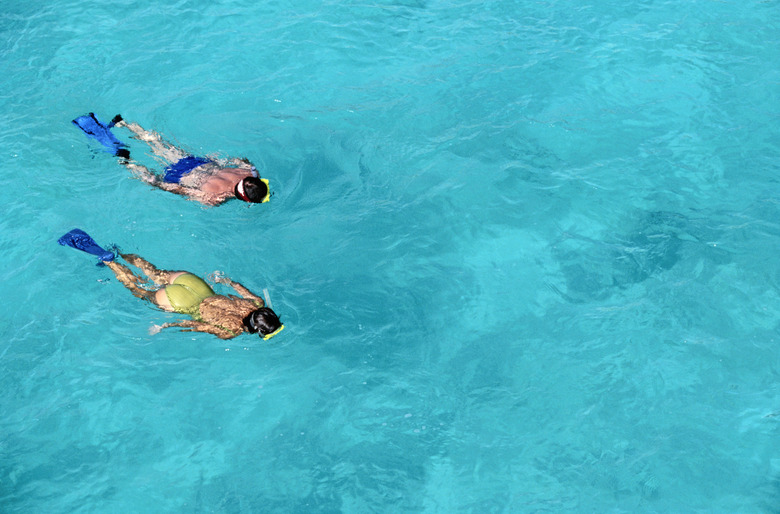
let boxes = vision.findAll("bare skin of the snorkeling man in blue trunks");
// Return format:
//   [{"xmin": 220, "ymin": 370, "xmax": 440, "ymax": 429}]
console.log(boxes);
[{"xmin": 116, "ymin": 120, "xmax": 253, "ymax": 206}]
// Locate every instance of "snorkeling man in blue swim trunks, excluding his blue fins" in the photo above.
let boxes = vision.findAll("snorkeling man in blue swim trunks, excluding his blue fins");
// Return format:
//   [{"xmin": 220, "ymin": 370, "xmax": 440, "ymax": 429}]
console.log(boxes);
[{"xmin": 112, "ymin": 115, "xmax": 270, "ymax": 206}]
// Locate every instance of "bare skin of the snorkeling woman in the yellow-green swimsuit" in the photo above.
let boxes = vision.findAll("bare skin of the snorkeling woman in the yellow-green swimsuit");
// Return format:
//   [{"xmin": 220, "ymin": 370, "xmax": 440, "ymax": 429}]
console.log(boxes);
[{"xmin": 104, "ymin": 254, "xmax": 265, "ymax": 339}]
